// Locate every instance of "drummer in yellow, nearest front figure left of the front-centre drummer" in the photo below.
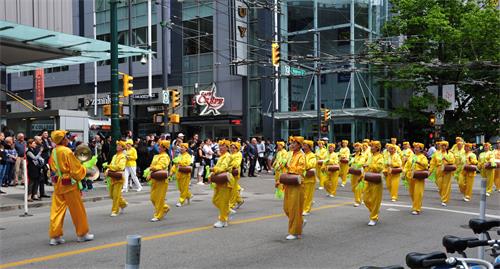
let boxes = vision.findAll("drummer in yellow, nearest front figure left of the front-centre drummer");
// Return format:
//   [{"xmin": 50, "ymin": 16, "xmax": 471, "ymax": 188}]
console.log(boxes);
[{"xmin": 209, "ymin": 140, "xmax": 236, "ymax": 228}]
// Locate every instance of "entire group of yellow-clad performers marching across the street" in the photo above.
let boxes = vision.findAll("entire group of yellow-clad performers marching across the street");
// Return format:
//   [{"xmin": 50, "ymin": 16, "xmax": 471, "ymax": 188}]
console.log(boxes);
[{"xmin": 49, "ymin": 130, "xmax": 500, "ymax": 245}]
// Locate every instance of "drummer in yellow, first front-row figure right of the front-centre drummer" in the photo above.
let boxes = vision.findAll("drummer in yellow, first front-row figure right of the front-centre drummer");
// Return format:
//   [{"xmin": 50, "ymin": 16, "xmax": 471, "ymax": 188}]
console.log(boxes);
[{"xmin": 363, "ymin": 141, "xmax": 385, "ymax": 226}]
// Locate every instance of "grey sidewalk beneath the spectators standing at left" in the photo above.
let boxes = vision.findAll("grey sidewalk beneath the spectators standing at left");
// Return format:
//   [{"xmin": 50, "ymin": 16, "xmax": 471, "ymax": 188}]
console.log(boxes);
[{"xmin": 0, "ymin": 181, "xmax": 150, "ymax": 212}]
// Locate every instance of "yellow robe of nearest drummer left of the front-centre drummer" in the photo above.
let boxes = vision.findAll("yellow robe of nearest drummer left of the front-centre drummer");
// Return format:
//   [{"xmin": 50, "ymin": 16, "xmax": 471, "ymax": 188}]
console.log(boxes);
[{"xmin": 212, "ymin": 152, "xmax": 235, "ymax": 222}]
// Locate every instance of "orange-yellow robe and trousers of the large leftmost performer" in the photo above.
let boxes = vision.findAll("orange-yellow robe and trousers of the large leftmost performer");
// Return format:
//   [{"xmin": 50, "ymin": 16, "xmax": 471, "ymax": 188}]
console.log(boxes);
[{"xmin": 49, "ymin": 146, "xmax": 89, "ymax": 238}]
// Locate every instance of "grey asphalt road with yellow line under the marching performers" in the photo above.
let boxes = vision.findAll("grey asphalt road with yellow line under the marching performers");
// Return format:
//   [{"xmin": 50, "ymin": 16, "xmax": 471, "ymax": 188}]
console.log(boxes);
[{"xmin": 0, "ymin": 175, "xmax": 500, "ymax": 268}]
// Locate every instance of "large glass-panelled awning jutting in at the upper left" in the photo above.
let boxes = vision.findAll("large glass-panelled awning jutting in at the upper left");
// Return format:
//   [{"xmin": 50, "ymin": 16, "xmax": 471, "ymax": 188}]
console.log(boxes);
[{"xmin": 0, "ymin": 21, "xmax": 150, "ymax": 73}]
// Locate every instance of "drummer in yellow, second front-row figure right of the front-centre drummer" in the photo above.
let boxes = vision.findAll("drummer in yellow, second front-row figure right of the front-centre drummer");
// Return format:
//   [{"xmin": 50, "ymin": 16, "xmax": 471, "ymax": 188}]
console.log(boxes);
[{"xmin": 405, "ymin": 142, "xmax": 429, "ymax": 215}]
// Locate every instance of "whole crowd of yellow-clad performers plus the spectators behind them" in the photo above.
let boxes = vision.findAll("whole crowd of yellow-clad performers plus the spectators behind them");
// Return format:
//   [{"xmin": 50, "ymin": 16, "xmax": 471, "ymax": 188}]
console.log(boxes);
[{"xmin": 0, "ymin": 126, "xmax": 500, "ymax": 245}]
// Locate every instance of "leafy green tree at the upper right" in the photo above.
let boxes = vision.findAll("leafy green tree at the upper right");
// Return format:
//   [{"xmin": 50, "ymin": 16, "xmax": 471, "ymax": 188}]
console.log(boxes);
[{"xmin": 368, "ymin": 0, "xmax": 500, "ymax": 139}]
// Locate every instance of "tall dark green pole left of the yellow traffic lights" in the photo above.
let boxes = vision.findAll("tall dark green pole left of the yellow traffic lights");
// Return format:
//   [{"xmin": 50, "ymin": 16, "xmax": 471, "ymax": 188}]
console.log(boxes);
[{"xmin": 109, "ymin": 0, "xmax": 120, "ymax": 154}]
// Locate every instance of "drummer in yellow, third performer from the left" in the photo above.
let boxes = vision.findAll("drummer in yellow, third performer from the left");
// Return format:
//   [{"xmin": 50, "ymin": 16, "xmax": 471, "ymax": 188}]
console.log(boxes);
[{"xmin": 148, "ymin": 140, "xmax": 170, "ymax": 222}]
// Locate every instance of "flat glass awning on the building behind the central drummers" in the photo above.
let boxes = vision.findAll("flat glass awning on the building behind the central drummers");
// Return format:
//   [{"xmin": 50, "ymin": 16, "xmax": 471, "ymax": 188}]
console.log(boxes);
[{"xmin": 264, "ymin": 107, "xmax": 392, "ymax": 120}]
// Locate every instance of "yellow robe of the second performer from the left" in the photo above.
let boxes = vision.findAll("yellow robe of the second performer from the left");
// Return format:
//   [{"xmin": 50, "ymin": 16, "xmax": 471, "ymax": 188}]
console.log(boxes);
[{"xmin": 108, "ymin": 152, "xmax": 127, "ymax": 214}]
